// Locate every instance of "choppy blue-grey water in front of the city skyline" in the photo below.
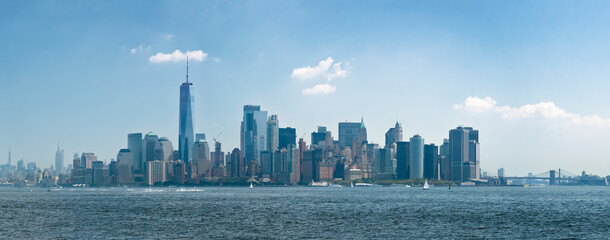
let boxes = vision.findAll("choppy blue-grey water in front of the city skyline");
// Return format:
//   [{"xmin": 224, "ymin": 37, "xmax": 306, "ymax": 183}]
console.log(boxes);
[{"xmin": 0, "ymin": 187, "xmax": 610, "ymax": 239}]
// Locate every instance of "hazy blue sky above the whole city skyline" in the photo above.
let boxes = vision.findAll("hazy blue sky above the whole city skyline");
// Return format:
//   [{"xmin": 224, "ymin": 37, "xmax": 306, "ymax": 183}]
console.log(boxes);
[{"xmin": 0, "ymin": 1, "xmax": 610, "ymax": 175}]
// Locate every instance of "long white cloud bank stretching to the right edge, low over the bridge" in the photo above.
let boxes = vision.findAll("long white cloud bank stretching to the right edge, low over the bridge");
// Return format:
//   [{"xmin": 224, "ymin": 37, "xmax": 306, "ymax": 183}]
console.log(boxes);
[{"xmin": 453, "ymin": 97, "xmax": 610, "ymax": 129}]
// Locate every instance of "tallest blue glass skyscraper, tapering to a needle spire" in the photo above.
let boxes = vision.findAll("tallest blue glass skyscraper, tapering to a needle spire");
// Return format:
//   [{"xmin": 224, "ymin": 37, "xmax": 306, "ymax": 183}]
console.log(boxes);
[{"xmin": 178, "ymin": 58, "xmax": 195, "ymax": 163}]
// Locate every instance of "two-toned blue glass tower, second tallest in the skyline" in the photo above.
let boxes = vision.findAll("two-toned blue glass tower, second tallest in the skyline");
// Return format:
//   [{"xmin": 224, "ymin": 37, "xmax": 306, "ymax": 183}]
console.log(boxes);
[{"xmin": 240, "ymin": 105, "xmax": 268, "ymax": 163}]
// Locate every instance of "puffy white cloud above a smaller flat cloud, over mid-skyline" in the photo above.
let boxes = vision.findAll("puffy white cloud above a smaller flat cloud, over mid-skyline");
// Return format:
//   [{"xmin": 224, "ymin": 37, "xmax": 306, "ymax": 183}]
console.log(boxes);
[{"xmin": 290, "ymin": 57, "xmax": 349, "ymax": 81}]
